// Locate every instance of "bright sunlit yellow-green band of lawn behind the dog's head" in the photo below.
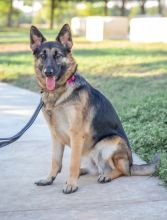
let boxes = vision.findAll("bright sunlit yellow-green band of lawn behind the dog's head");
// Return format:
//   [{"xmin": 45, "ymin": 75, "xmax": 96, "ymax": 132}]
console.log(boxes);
[{"xmin": 0, "ymin": 38, "xmax": 167, "ymax": 79}]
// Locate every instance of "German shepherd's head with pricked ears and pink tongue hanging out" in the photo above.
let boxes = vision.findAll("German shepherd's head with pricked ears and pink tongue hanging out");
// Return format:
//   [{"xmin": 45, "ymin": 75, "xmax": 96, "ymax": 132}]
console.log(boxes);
[{"xmin": 30, "ymin": 24, "xmax": 77, "ymax": 91}]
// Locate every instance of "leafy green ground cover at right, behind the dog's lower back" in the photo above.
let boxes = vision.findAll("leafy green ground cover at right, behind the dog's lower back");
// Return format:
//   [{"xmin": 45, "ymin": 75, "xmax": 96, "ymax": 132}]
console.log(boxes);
[{"xmin": 122, "ymin": 91, "xmax": 167, "ymax": 184}]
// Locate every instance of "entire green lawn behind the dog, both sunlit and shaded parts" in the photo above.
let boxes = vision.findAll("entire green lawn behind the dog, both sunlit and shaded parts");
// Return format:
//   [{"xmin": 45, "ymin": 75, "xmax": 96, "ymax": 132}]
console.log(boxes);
[{"xmin": 0, "ymin": 30, "xmax": 167, "ymax": 184}]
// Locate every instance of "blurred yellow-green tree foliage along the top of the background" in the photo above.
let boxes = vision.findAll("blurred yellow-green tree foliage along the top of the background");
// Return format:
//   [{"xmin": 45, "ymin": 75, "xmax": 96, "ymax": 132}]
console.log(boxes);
[{"xmin": 0, "ymin": 0, "xmax": 164, "ymax": 27}]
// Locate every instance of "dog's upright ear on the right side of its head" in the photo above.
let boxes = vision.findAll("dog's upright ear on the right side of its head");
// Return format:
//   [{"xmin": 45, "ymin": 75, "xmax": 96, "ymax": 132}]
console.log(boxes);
[{"xmin": 56, "ymin": 24, "xmax": 73, "ymax": 50}]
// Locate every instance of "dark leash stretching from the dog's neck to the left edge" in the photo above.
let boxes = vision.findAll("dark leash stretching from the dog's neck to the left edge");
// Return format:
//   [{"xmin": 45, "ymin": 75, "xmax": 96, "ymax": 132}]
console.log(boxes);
[{"xmin": 0, "ymin": 99, "xmax": 44, "ymax": 148}]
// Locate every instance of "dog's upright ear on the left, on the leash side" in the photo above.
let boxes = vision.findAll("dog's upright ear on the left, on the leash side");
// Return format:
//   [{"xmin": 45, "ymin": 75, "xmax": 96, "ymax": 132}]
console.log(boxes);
[{"xmin": 30, "ymin": 26, "xmax": 46, "ymax": 51}]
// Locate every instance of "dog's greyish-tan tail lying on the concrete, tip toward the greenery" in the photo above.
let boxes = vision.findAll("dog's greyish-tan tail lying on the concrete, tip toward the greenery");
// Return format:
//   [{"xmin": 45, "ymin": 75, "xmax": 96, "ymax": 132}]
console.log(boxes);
[{"xmin": 130, "ymin": 154, "xmax": 160, "ymax": 176}]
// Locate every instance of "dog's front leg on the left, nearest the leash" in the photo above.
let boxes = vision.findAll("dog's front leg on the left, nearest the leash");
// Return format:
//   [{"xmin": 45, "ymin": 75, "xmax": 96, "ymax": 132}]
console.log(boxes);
[{"xmin": 35, "ymin": 137, "xmax": 64, "ymax": 186}]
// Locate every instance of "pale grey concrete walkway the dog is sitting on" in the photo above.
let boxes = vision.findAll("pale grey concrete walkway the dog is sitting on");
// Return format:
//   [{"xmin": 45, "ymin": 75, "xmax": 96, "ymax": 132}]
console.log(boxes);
[{"xmin": 0, "ymin": 83, "xmax": 167, "ymax": 220}]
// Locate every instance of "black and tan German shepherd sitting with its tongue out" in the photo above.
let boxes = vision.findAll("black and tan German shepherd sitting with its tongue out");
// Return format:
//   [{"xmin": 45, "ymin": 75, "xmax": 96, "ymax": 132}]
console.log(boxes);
[{"xmin": 30, "ymin": 24, "xmax": 159, "ymax": 194}]
